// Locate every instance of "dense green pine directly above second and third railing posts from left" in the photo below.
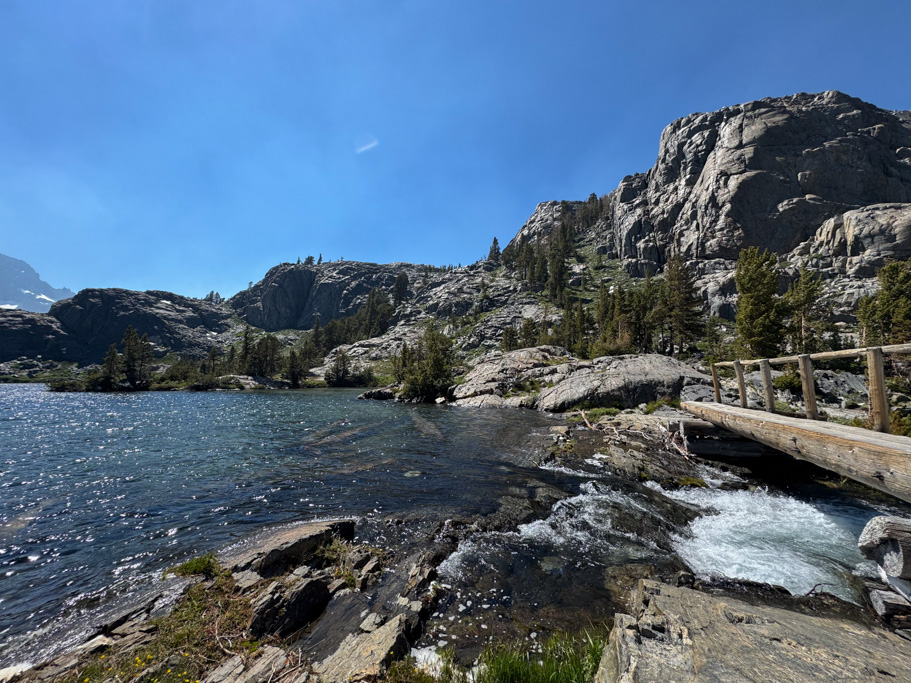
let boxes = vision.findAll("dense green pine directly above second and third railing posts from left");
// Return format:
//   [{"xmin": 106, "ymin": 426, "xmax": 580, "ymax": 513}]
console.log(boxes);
[{"xmin": 734, "ymin": 247, "xmax": 785, "ymax": 358}]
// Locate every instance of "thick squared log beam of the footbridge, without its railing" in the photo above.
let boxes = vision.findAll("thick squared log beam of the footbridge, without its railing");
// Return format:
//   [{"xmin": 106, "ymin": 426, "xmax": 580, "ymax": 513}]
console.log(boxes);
[{"xmin": 681, "ymin": 401, "xmax": 911, "ymax": 503}]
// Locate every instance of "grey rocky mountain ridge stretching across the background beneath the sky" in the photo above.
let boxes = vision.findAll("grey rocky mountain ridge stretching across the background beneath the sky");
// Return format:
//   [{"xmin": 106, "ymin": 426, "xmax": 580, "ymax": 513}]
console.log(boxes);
[{"xmin": 0, "ymin": 91, "xmax": 911, "ymax": 361}]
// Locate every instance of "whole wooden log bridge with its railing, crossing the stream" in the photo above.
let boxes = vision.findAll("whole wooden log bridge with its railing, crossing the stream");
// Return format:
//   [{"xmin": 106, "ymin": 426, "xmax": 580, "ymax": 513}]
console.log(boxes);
[{"xmin": 681, "ymin": 344, "xmax": 911, "ymax": 503}]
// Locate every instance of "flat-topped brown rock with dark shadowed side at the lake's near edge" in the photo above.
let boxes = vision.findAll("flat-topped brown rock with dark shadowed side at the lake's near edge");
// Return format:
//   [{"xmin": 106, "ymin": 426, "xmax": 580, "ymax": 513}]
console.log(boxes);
[{"xmin": 221, "ymin": 520, "xmax": 354, "ymax": 576}]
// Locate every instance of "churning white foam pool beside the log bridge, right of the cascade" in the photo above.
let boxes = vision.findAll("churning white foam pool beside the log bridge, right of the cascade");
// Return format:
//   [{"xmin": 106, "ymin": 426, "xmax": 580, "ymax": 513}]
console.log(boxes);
[{"xmin": 665, "ymin": 489, "xmax": 875, "ymax": 601}]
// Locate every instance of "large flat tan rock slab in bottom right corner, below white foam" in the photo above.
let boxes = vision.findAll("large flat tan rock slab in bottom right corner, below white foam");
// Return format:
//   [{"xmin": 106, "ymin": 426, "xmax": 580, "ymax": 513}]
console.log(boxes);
[{"xmin": 595, "ymin": 579, "xmax": 911, "ymax": 683}]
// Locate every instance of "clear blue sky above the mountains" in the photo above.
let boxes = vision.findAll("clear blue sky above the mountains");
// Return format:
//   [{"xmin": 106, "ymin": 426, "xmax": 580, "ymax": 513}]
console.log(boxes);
[{"xmin": 0, "ymin": 0, "xmax": 911, "ymax": 296}]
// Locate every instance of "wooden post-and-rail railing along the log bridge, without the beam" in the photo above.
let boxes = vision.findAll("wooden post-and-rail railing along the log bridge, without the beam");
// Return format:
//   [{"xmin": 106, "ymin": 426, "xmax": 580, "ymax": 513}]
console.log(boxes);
[{"xmin": 712, "ymin": 344, "xmax": 911, "ymax": 433}]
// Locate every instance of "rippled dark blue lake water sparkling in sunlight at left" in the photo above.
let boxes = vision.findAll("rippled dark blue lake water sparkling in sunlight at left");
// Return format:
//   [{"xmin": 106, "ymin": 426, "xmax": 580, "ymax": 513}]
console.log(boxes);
[{"xmin": 0, "ymin": 385, "xmax": 548, "ymax": 666}]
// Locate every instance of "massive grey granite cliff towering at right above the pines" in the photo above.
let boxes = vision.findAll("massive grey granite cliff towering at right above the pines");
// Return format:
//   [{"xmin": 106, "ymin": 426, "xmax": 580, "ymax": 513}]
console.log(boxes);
[{"xmin": 514, "ymin": 91, "xmax": 911, "ymax": 314}]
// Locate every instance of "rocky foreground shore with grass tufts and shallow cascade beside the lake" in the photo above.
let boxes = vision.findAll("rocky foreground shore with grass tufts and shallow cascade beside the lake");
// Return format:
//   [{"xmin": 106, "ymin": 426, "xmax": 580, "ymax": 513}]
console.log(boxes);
[{"xmin": 0, "ymin": 400, "xmax": 911, "ymax": 683}]
